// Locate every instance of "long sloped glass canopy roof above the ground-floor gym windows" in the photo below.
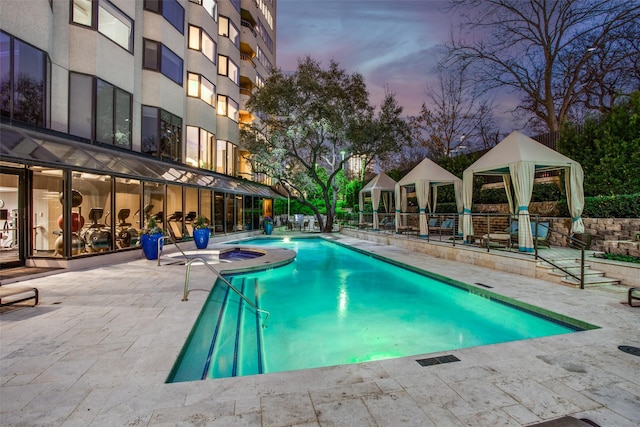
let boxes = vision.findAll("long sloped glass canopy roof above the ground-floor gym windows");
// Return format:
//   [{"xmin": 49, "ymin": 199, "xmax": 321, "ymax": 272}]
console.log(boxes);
[{"xmin": 0, "ymin": 123, "xmax": 282, "ymax": 198}]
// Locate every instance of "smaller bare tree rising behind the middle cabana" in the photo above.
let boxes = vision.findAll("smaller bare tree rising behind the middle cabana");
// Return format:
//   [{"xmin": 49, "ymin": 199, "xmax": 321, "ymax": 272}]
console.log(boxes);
[{"xmin": 410, "ymin": 68, "xmax": 499, "ymax": 161}]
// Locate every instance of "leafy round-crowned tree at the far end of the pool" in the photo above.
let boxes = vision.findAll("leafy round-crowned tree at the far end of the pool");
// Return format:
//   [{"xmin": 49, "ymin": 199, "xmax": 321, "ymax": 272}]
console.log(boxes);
[{"xmin": 240, "ymin": 57, "xmax": 408, "ymax": 232}]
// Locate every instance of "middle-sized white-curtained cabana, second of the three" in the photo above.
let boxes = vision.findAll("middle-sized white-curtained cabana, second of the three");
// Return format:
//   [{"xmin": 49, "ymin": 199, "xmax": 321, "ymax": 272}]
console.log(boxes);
[{"xmin": 395, "ymin": 158, "xmax": 462, "ymax": 237}]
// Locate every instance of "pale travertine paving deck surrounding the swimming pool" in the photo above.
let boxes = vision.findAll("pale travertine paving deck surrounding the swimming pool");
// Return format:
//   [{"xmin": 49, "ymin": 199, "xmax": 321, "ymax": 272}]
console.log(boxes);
[{"xmin": 0, "ymin": 235, "xmax": 640, "ymax": 427}]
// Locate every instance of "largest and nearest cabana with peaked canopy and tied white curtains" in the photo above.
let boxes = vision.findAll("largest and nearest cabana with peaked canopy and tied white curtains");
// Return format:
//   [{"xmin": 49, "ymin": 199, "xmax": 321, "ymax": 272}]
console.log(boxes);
[{"xmin": 462, "ymin": 131, "xmax": 584, "ymax": 252}]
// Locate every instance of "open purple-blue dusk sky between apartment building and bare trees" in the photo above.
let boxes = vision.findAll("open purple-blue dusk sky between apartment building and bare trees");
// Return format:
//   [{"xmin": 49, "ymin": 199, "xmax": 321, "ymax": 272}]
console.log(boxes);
[{"xmin": 276, "ymin": 0, "xmax": 470, "ymax": 115}]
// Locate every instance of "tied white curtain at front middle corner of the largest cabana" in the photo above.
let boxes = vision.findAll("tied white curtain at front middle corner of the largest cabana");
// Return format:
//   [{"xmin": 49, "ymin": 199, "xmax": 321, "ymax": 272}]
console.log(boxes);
[{"xmin": 509, "ymin": 162, "xmax": 536, "ymax": 252}]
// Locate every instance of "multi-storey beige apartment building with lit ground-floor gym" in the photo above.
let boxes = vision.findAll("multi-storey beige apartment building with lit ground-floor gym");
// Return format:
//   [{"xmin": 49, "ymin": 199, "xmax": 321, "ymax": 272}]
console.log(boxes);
[{"xmin": 0, "ymin": 0, "xmax": 278, "ymax": 267}]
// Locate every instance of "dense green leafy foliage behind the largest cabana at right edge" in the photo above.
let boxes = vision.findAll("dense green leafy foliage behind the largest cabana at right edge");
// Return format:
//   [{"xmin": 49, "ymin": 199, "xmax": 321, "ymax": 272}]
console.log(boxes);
[{"xmin": 558, "ymin": 92, "xmax": 640, "ymax": 196}]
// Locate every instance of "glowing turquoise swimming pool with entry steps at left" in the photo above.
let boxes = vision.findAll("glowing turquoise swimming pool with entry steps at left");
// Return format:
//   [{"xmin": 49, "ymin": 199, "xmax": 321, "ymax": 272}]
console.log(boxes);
[{"xmin": 168, "ymin": 238, "xmax": 593, "ymax": 382}]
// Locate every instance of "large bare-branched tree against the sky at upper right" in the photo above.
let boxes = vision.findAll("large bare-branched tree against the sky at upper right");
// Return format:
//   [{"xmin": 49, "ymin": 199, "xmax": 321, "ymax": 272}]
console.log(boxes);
[{"xmin": 447, "ymin": 0, "xmax": 640, "ymax": 131}]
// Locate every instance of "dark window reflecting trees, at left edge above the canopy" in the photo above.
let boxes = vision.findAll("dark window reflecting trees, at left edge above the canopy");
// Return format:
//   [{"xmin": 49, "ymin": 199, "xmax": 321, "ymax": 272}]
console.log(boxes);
[{"xmin": 0, "ymin": 33, "xmax": 48, "ymax": 127}]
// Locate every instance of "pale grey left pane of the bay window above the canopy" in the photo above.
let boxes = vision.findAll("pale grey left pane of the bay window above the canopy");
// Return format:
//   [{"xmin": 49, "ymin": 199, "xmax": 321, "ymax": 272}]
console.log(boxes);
[{"xmin": 69, "ymin": 73, "xmax": 93, "ymax": 139}]
